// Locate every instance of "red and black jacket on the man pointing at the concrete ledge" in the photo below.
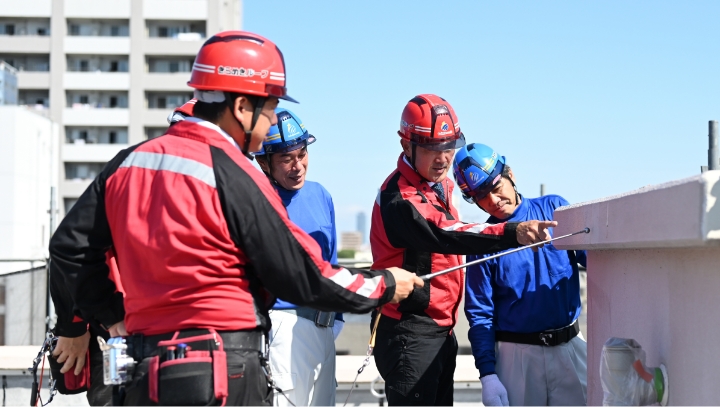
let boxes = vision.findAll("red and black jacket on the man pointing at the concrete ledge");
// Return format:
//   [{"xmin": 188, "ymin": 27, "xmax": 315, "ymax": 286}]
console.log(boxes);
[{"xmin": 370, "ymin": 155, "xmax": 519, "ymax": 336}]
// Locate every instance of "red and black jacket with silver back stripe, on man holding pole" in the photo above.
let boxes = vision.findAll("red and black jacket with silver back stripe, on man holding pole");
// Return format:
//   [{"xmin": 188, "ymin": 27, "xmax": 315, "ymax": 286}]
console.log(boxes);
[{"xmin": 50, "ymin": 118, "xmax": 395, "ymax": 335}]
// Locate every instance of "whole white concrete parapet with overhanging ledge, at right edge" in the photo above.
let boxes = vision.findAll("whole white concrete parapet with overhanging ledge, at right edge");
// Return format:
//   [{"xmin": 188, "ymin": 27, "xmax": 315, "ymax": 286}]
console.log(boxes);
[{"xmin": 554, "ymin": 171, "xmax": 720, "ymax": 405}]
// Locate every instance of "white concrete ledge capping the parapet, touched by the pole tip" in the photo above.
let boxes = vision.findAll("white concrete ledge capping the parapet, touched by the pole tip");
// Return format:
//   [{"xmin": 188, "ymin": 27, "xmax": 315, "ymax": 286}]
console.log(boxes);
[{"xmin": 554, "ymin": 171, "xmax": 720, "ymax": 250}]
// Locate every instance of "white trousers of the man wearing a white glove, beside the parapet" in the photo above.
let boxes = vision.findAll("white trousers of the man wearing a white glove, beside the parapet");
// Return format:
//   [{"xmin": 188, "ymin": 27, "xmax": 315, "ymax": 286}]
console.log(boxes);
[{"xmin": 495, "ymin": 334, "xmax": 587, "ymax": 406}]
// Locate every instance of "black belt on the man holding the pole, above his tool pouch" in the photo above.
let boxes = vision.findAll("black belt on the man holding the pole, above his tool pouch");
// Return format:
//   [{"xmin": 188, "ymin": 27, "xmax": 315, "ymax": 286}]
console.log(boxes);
[{"xmin": 125, "ymin": 329, "xmax": 265, "ymax": 362}]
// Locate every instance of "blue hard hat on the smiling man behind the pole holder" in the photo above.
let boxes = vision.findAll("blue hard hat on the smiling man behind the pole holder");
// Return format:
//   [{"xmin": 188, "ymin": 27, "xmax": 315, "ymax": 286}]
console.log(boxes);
[{"xmin": 255, "ymin": 108, "xmax": 315, "ymax": 155}]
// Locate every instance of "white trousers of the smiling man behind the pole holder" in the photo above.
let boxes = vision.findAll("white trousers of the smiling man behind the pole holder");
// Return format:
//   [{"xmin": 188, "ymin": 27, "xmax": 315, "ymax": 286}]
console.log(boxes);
[{"xmin": 270, "ymin": 310, "xmax": 335, "ymax": 406}]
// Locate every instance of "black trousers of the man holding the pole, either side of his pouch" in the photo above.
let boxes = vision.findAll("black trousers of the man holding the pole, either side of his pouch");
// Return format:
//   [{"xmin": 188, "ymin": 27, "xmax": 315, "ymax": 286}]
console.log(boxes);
[{"xmin": 123, "ymin": 348, "xmax": 273, "ymax": 406}]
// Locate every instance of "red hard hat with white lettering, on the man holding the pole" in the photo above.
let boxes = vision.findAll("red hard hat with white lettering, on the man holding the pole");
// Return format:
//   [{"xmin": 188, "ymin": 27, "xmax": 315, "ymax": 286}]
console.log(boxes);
[{"xmin": 188, "ymin": 31, "xmax": 297, "ymax": 103}]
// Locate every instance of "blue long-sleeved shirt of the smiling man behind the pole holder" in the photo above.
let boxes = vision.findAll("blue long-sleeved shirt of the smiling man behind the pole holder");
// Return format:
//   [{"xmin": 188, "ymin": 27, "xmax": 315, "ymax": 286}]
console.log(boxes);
[{"xmin": 273, "ymin": 181, "xmax": 342, "ymax": 312}]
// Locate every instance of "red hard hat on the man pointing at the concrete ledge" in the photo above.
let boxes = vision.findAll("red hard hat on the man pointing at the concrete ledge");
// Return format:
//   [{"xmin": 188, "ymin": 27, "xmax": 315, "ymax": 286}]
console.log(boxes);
[{"xmin": 398, "ymin": 94, "xmax": 465, "ymax": 150}]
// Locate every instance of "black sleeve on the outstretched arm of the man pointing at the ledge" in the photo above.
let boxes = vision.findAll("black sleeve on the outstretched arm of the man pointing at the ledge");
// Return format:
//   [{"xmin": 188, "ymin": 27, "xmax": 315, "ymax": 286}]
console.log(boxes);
[{"xmin": 380, "ymin": 184, "xmax": 521, "ymax": 255}]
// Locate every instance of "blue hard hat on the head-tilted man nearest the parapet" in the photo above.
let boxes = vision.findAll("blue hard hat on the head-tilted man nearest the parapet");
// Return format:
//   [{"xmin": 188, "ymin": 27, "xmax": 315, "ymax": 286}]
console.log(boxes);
[{"xmin": 453, "ymin": 143, "xmax": 505, "ymax": 203}]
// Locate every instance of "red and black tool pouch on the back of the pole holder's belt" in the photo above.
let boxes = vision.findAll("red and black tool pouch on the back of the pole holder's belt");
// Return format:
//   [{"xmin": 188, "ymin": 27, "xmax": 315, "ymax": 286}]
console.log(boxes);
[{"xmin": 148, "ymin": 331, "xmax": 228, "ymax": 406}]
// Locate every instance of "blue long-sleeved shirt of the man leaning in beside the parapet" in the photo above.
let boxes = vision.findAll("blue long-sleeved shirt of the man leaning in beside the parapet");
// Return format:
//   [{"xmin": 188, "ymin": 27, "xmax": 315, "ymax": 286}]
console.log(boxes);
[{"xmin": 465, "ymin": 195, "xmax": 585, "ymax": 376}]
